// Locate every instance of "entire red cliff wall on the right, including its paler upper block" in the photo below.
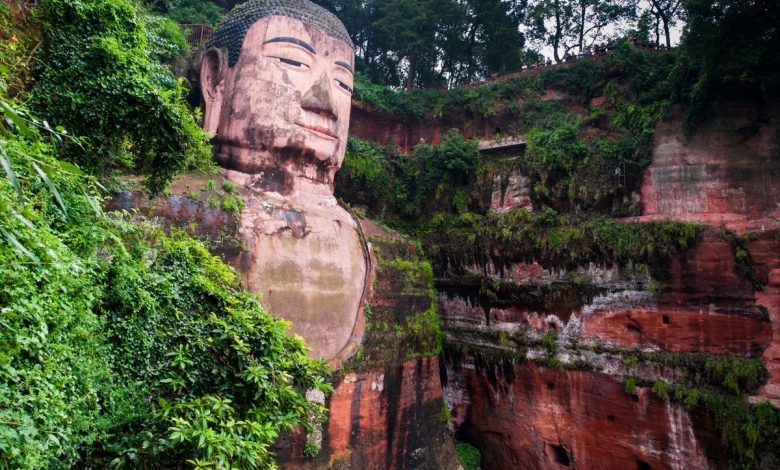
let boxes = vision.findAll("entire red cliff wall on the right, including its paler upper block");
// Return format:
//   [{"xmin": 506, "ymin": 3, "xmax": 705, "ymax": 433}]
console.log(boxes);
[{"xmin": 426, "ymin": 93, "xmax": 780, "ymax": 469}]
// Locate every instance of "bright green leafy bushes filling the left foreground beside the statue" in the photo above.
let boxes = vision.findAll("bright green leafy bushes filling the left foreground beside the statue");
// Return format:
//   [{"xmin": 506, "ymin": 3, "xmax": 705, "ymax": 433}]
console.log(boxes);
[{"xmin": 0, "ymin": 0, "xmax": 329, "ymax": 468}]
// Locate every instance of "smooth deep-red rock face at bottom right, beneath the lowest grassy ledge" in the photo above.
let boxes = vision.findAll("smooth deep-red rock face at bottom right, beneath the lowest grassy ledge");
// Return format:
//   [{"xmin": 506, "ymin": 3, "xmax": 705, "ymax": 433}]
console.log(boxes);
[{"xmin": 446, "ymin": 354, "xmax": 710, "ymax": 469}]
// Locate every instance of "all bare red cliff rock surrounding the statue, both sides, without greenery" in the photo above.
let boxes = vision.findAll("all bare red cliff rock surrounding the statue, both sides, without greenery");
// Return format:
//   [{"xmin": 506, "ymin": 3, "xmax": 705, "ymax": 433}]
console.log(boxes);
[{"xmin": 114, "ymin": 78, "xmax": 780, "ymax": 469}]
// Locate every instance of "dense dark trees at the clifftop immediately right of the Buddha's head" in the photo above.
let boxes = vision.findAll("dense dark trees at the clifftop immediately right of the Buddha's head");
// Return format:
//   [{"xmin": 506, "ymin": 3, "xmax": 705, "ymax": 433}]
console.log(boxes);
[{"xmin": 315, "ymin": 0, "xmax": 536, "ymax": 89}]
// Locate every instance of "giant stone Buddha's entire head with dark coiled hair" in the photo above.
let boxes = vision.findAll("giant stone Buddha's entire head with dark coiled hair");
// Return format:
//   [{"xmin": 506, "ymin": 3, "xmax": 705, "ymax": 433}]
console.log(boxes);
[{"xmin": 200, "ymin": 0, "xmax": 354, "ymax": 194}]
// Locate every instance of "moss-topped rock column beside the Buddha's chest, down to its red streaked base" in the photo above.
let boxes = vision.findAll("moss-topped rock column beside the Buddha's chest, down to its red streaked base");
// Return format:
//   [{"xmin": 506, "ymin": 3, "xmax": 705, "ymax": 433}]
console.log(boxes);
[{"xmin": 279, "ymin": 219, "xmax": 458, "ymax": 470}]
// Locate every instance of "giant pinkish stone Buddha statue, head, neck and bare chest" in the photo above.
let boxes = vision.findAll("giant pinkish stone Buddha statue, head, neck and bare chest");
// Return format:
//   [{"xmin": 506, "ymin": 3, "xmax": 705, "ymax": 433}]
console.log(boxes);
[{"xmin": 200, "ymin": 0, "xmax": 369, "ymax": 362}]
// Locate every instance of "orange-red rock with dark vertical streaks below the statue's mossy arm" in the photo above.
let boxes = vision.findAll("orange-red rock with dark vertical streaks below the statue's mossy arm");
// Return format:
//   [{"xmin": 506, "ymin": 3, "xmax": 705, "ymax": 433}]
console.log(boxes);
[{"xmin": 278, "ymin": 357, "xmax": 450, "ymax": 470}]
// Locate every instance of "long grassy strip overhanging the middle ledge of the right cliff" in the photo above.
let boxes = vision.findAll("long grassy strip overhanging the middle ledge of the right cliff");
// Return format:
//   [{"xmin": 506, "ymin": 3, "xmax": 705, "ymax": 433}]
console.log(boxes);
[{"xmin": 420, "ymin": 209, "xmax": 701, "ymax": 269}]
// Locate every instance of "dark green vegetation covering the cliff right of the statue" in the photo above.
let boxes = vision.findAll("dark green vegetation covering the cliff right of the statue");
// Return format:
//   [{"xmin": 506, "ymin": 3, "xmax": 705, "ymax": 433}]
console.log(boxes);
[{"xmin": 337, "ymin": 4, "xmax": 780, "ymax": 468}]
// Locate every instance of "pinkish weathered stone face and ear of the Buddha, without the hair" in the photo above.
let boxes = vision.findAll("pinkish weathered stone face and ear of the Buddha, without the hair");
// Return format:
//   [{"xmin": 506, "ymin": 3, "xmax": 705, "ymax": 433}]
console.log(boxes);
[{"xmin": 201, "ymin": 16, "xmax": 354, "ymax": 179}]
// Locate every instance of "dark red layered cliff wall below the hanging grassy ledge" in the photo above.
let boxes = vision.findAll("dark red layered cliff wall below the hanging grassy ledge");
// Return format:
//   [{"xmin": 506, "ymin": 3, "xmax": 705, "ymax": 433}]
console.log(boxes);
[{"xmin": 437, "ymin": 226, "xmax": 780, "ymax": 469}]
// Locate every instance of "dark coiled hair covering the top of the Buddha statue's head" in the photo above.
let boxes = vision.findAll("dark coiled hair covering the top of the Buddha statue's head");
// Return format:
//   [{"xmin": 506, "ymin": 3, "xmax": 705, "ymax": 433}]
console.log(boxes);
[{"xmin": 206, "ymin": 0, "xmax": 355, "ymax": 67}]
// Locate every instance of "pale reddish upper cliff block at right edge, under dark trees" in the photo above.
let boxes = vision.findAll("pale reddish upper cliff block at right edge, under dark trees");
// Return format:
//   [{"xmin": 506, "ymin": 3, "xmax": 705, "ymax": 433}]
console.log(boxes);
[{"xmin": 641, "ymin": 93, "xmax": 780, "ymax": 231}]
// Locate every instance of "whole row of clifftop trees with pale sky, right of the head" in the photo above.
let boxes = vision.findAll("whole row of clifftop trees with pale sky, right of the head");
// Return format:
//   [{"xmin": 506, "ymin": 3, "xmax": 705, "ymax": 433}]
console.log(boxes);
[{"xmin": 308, "ymin": 0, "xmax": 680, "ymax": 89}]
